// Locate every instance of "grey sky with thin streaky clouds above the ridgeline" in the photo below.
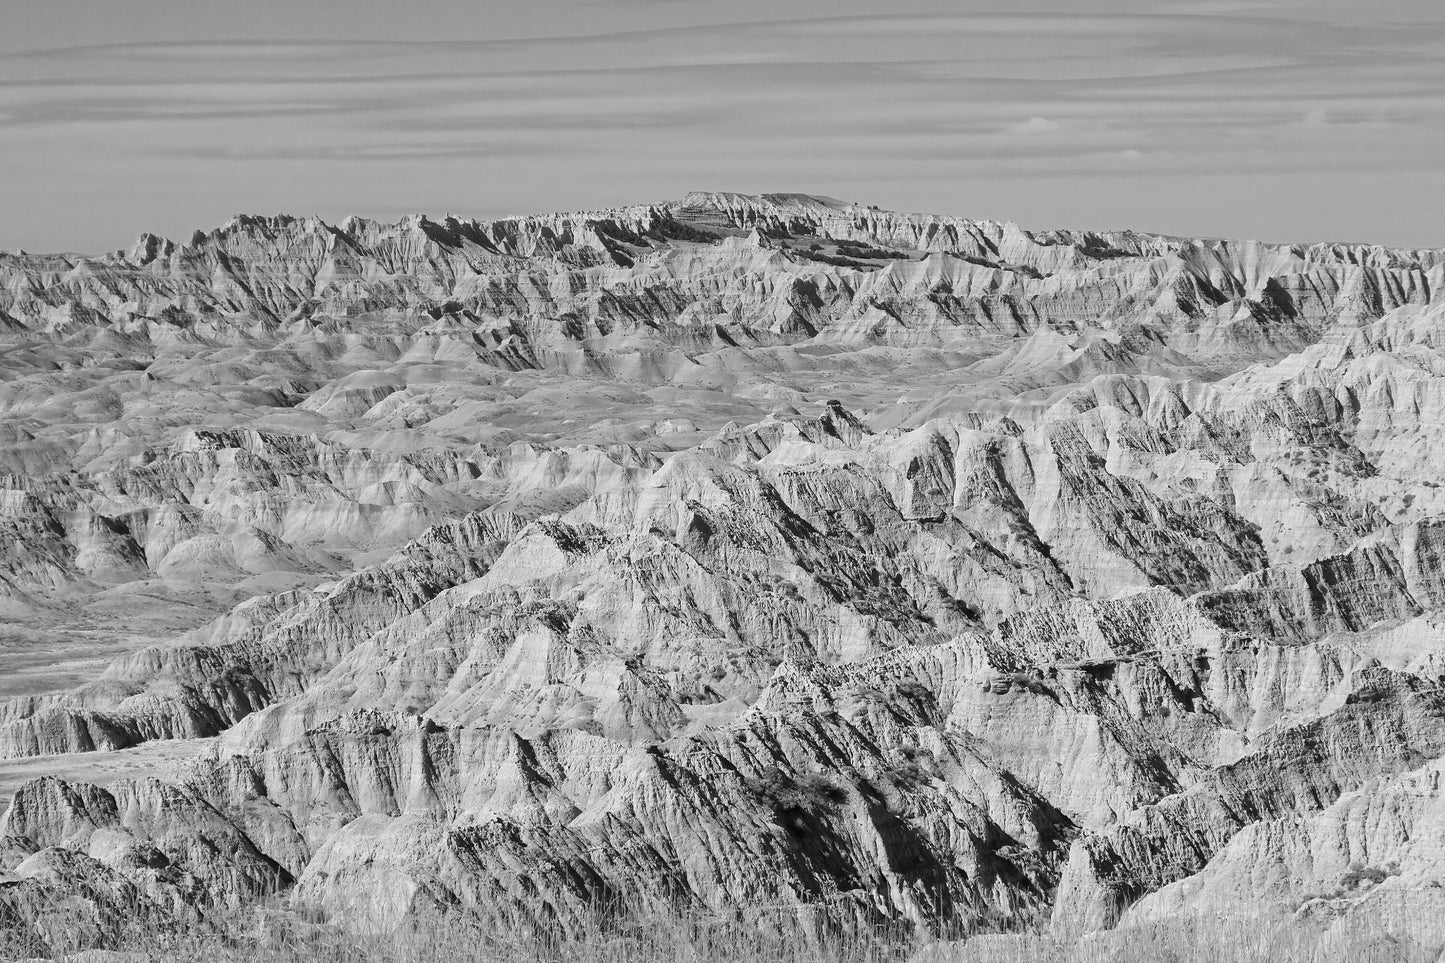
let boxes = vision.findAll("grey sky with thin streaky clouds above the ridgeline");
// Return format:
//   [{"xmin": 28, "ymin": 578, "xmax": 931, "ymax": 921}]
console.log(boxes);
[{"xmin": 0, "ymin": 0, "xmax": 1445, "ymax": 253}]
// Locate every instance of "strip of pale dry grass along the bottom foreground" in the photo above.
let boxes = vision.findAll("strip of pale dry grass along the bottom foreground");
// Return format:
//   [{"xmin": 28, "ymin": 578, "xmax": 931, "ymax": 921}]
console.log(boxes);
[{"xmin": 0, "ymin": 901, "xmax": 1445, "ymax": 963}]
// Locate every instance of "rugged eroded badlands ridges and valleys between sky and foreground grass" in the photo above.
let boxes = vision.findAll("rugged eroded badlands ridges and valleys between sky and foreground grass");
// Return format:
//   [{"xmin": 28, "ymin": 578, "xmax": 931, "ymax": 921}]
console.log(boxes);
[{"xmin": 0, "ymin": 194, "xmax": 1445, "ymax": 934}]
